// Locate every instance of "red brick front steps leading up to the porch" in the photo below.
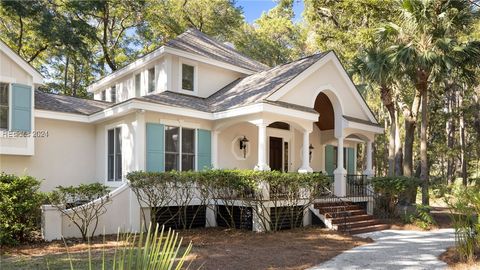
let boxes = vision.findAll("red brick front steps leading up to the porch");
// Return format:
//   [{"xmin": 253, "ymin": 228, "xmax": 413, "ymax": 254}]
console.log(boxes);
[{"xmin": 310, "ymin": 202, "xmax": 390, "ymax": 234}]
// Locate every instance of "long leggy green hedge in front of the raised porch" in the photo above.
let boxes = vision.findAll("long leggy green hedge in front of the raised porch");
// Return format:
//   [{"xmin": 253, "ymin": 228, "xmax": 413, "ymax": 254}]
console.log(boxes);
[{"xmin": 127, "ymin": 170, "xmax": 330, "ymax": 230}]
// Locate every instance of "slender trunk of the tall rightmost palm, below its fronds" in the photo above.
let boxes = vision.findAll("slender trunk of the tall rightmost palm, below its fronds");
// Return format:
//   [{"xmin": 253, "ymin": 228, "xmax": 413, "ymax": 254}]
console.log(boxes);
[{"xmin": 420, "ymin": 88, "xmax": 429, "ymax": 205}]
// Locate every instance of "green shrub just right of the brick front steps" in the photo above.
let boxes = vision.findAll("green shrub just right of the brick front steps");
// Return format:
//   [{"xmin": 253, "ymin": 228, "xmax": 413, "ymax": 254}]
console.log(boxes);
[{"xmin": 371, "ymin": 176, "xmax": 420, "ymax": 217}]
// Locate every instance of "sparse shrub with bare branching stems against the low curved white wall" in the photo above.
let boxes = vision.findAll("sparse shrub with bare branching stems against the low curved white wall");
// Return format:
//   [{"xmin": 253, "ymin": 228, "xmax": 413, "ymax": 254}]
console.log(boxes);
[{"xmin": 49, "ymin": 183, "xmax": 110, "ymax": 241}]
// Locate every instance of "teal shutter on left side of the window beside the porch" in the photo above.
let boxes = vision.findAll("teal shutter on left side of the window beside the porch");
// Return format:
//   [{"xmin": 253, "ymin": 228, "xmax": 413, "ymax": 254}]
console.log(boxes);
[{"xmin": 146, "ymin": 123, "xmax": 165, "ymax": 172}]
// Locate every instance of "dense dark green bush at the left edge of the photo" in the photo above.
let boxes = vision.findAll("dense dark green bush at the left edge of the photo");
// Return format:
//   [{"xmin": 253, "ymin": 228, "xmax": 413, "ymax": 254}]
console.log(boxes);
[{"xmin": 0, "ymin": 173, "xmax": 45, "ymax": 245}]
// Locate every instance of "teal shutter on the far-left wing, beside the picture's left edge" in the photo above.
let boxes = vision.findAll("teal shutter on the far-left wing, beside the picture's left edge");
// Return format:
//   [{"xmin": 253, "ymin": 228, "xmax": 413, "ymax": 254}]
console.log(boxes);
[{"xmin": 11, "ymin": 83, "xmax": 32, "ymax": 132}]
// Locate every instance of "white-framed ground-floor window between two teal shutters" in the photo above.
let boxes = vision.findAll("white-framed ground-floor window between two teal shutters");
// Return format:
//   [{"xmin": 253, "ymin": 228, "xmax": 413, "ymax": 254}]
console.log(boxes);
[{"xmin": 165, "ymin": 126, "xmax": 195, "ymax": 171}]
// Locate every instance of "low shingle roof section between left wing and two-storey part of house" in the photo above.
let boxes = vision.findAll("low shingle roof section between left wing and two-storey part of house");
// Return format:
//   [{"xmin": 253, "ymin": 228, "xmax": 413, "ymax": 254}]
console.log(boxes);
[{"xmin": 35, "ymin": 90, "xmax": 113, "ymax": 115}]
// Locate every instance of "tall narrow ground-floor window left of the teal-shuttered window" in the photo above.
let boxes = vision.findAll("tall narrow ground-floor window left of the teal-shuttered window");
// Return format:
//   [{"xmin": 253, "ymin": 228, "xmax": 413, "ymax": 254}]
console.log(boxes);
[{"xmin": 107, "ymin": 127, "xmax": 122, "ymax": 181}]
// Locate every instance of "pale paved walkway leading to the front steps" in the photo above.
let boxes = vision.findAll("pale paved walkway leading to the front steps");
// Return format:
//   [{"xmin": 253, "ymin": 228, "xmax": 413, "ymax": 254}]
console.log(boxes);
[{"xmin": 311, "ymin": 229, "xmax": 455, "ymax": 270}]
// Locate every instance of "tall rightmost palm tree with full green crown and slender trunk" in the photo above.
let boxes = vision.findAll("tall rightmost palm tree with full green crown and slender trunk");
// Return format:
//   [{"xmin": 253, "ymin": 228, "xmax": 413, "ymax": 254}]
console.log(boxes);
[{"xmin": 378, "ymin": 0, "xmax": 480, "ymax": 204}]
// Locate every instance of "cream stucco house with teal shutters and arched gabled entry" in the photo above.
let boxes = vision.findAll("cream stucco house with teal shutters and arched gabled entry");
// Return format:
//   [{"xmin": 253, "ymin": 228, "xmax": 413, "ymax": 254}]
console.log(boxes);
[{"xmin": 0, "ymin": 30, "xmax": 383, "ymax": 238}]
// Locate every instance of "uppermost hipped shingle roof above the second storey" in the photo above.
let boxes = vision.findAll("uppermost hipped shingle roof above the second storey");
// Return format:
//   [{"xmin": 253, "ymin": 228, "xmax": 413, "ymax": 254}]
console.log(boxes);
[{"xmin": 165, "ymin": 28, "xmax": 269, "ymax": 72}]
